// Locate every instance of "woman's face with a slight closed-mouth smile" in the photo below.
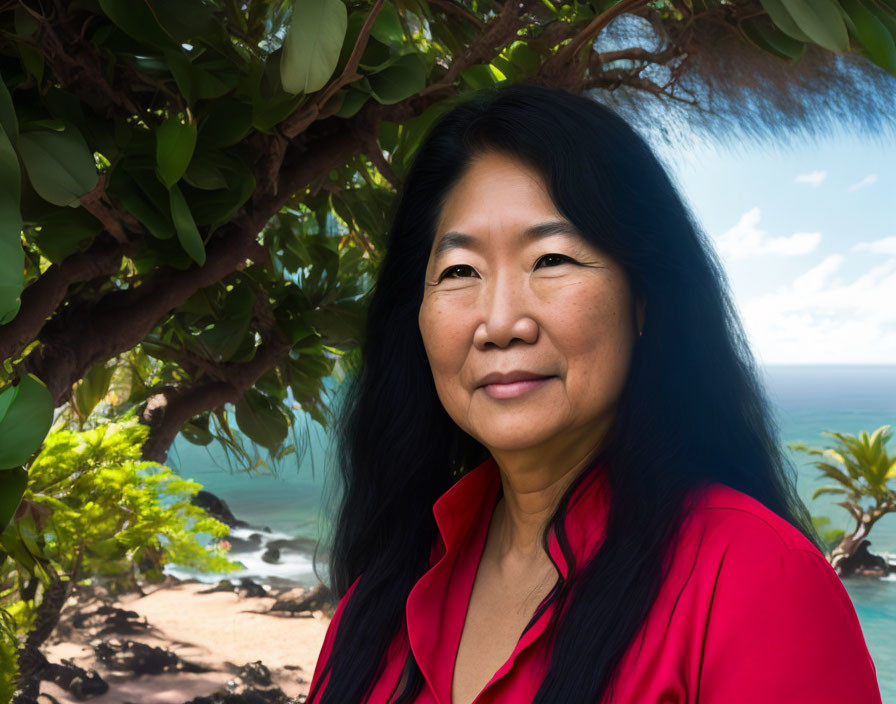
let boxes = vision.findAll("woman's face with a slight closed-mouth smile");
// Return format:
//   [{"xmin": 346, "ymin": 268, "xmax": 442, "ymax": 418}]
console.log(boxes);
[{"xmin": 418, "ymin": 153, "xmax": 643, "ymax": 452}]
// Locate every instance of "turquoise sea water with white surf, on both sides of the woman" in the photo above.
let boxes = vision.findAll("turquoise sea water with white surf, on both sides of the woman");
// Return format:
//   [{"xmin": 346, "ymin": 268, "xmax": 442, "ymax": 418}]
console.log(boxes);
[{"xmin": 169, "ymin": 365, "xmax": 896, "ymax": 704}]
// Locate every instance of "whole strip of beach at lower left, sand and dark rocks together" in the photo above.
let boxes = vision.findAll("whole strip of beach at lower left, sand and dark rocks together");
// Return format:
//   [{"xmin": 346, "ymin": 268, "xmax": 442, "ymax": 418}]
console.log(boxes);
[{"xmin": 28, "ymin": 576, "xmax": 335, "ymax": 704}]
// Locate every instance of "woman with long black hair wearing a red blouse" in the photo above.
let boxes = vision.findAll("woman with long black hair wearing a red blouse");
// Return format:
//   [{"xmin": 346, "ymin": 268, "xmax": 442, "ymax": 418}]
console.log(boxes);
[{"xmin": 308, "ymin": 84, "xmax": 880, "ymax": 704}]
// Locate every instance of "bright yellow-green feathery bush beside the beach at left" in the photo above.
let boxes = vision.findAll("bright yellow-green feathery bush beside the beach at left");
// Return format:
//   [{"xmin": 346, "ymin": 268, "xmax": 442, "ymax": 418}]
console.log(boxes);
[{"xmin": 0, "ymin": 418, "xmax": 240, "ymax": 632}]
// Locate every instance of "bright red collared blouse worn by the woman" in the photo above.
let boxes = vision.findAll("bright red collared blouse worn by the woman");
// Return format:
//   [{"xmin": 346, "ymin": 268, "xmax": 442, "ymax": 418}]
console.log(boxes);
[{"xmin": 309, "ymin": 458, "xmax": 881, "ymax": 704}]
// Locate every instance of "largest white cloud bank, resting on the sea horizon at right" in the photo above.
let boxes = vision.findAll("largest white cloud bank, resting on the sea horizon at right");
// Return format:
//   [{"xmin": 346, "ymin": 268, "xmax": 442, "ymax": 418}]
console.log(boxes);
[{"xmin": 739, "ymin": 253, "xmax": 896, "ymax": 364}]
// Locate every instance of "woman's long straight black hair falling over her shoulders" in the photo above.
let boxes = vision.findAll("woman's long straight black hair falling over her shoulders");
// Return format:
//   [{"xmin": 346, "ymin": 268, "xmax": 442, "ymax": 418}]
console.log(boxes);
[{"xmin": 309, "ymin": 83, "xmax": 823, "ymax": 704}]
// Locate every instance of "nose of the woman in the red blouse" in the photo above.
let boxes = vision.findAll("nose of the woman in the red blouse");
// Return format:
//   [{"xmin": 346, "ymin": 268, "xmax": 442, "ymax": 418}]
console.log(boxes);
[{"xmin": 473, "ymin": 275, "xmax": 538, "ymax": 349}]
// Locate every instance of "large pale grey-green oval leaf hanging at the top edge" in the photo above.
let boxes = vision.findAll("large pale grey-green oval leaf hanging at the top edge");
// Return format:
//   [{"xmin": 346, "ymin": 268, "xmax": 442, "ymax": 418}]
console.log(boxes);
[{"xmin": 280, "ymin": 0, "xmax": 348, "ymax": 94}]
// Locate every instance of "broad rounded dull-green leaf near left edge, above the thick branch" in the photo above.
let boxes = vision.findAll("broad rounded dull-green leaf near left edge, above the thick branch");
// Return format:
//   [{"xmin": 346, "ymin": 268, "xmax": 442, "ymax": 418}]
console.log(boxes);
[{"xmin": 19, "ymin": 124, "xmax": 98, "ymax": 205}]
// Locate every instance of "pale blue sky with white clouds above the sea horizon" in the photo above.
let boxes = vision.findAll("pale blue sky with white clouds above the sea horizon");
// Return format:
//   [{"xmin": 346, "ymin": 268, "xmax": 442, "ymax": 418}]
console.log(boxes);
[{"xmin": 655, "ymin": 129, "xmax": 896, "ymax": 364}]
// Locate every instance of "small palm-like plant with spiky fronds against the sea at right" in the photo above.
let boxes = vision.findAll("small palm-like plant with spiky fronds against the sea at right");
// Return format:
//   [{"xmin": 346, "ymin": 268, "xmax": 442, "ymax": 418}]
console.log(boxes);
[{"xmin": 788, "ymin": 425, "xmax": 896, "ymax": 574}]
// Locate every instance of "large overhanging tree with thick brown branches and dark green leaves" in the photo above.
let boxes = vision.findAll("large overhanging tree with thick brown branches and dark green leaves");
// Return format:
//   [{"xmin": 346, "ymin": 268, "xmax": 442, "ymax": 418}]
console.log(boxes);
[{"xmin": 0, "ymin": 0, "xmax": 896, "ymax": 500}]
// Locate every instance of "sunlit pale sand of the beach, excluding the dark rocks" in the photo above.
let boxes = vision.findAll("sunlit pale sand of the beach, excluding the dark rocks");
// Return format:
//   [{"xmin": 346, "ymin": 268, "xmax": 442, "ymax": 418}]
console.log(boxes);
[{"xmin": 32, "ymin": 577, "xmax": 332, "ymax": 704}]
